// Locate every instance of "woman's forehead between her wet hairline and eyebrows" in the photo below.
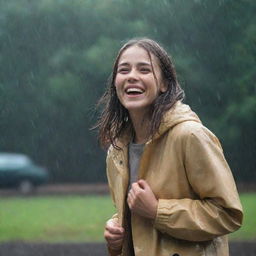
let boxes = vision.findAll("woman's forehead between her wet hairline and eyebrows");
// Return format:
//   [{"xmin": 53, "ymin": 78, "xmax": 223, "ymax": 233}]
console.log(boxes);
[{"xmin": 118, "ymin": 45, "xmax": 158, "ymax": 65}]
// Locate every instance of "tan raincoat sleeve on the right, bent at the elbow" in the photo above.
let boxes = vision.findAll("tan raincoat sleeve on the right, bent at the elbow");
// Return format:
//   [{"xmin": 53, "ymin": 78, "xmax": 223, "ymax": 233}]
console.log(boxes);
[{"xmin": 154, "ymin": 127, "xmax": 243, "ymax": 241}]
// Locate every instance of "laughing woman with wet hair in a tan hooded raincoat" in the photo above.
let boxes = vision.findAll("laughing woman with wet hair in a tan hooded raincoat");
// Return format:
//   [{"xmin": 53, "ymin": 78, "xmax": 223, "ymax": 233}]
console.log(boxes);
[{"xmin": 95, "ymin": 38, "xmax": 242, "ymax": 256}]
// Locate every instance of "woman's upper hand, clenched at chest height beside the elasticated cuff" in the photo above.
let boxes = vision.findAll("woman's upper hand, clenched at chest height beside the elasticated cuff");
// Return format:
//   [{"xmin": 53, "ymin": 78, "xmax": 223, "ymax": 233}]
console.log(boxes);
[{"xmin": 127, "ymin": 180, "xmax": 158, "ymax": 219}]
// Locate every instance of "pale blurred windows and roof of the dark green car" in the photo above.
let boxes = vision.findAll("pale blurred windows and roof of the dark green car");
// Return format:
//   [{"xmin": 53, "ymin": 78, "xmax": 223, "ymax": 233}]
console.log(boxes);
[{"xmin": 0, "ymin": 154, "xmax": 32, "ymax": 168}]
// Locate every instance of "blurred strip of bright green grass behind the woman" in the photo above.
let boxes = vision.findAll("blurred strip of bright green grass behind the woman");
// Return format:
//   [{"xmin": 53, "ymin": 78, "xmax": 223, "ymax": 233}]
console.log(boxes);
[{"xmin": 0, "ymin": 194, "xmax": 256, "ymax": 242}]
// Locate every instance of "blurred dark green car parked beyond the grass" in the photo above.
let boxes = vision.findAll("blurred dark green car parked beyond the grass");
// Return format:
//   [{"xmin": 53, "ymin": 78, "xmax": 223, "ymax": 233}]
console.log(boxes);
[{"xmin": 0, "ymin": 153, "xmax": 49, "ymax": 193}]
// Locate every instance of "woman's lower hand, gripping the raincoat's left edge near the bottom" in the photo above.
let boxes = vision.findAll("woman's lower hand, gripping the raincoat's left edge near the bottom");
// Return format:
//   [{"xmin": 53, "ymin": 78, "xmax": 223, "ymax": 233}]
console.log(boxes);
[{"xmin": 104, "ymin": 219, "xmax": 124, "ymax": 251}]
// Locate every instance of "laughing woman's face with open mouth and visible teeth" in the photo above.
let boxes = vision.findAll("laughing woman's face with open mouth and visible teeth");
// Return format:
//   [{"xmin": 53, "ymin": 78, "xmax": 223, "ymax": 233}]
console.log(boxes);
[{"xmin": 115, "ymin": 45, "xmax": 167, "ymax": 117}]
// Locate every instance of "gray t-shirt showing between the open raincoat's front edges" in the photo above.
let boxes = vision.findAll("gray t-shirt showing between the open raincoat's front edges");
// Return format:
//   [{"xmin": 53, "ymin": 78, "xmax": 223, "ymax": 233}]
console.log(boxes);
[{"xmin": 129, "ymin": 143, "xmax": 145, "ymax": 189}]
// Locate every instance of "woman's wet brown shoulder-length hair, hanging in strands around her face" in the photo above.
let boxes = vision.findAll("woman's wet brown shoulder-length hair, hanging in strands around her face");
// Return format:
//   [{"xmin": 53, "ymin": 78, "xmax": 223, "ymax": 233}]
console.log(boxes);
[{"xmin": 95, "ymin": 38, "xmax": 184, "ymax": 149}]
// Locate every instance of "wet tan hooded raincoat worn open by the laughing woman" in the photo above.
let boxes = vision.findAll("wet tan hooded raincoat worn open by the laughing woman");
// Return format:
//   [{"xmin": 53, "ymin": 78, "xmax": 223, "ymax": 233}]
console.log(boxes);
[{"xmin": 107, "ymin": 102, "xmax": 243, "ymax": 256}]
